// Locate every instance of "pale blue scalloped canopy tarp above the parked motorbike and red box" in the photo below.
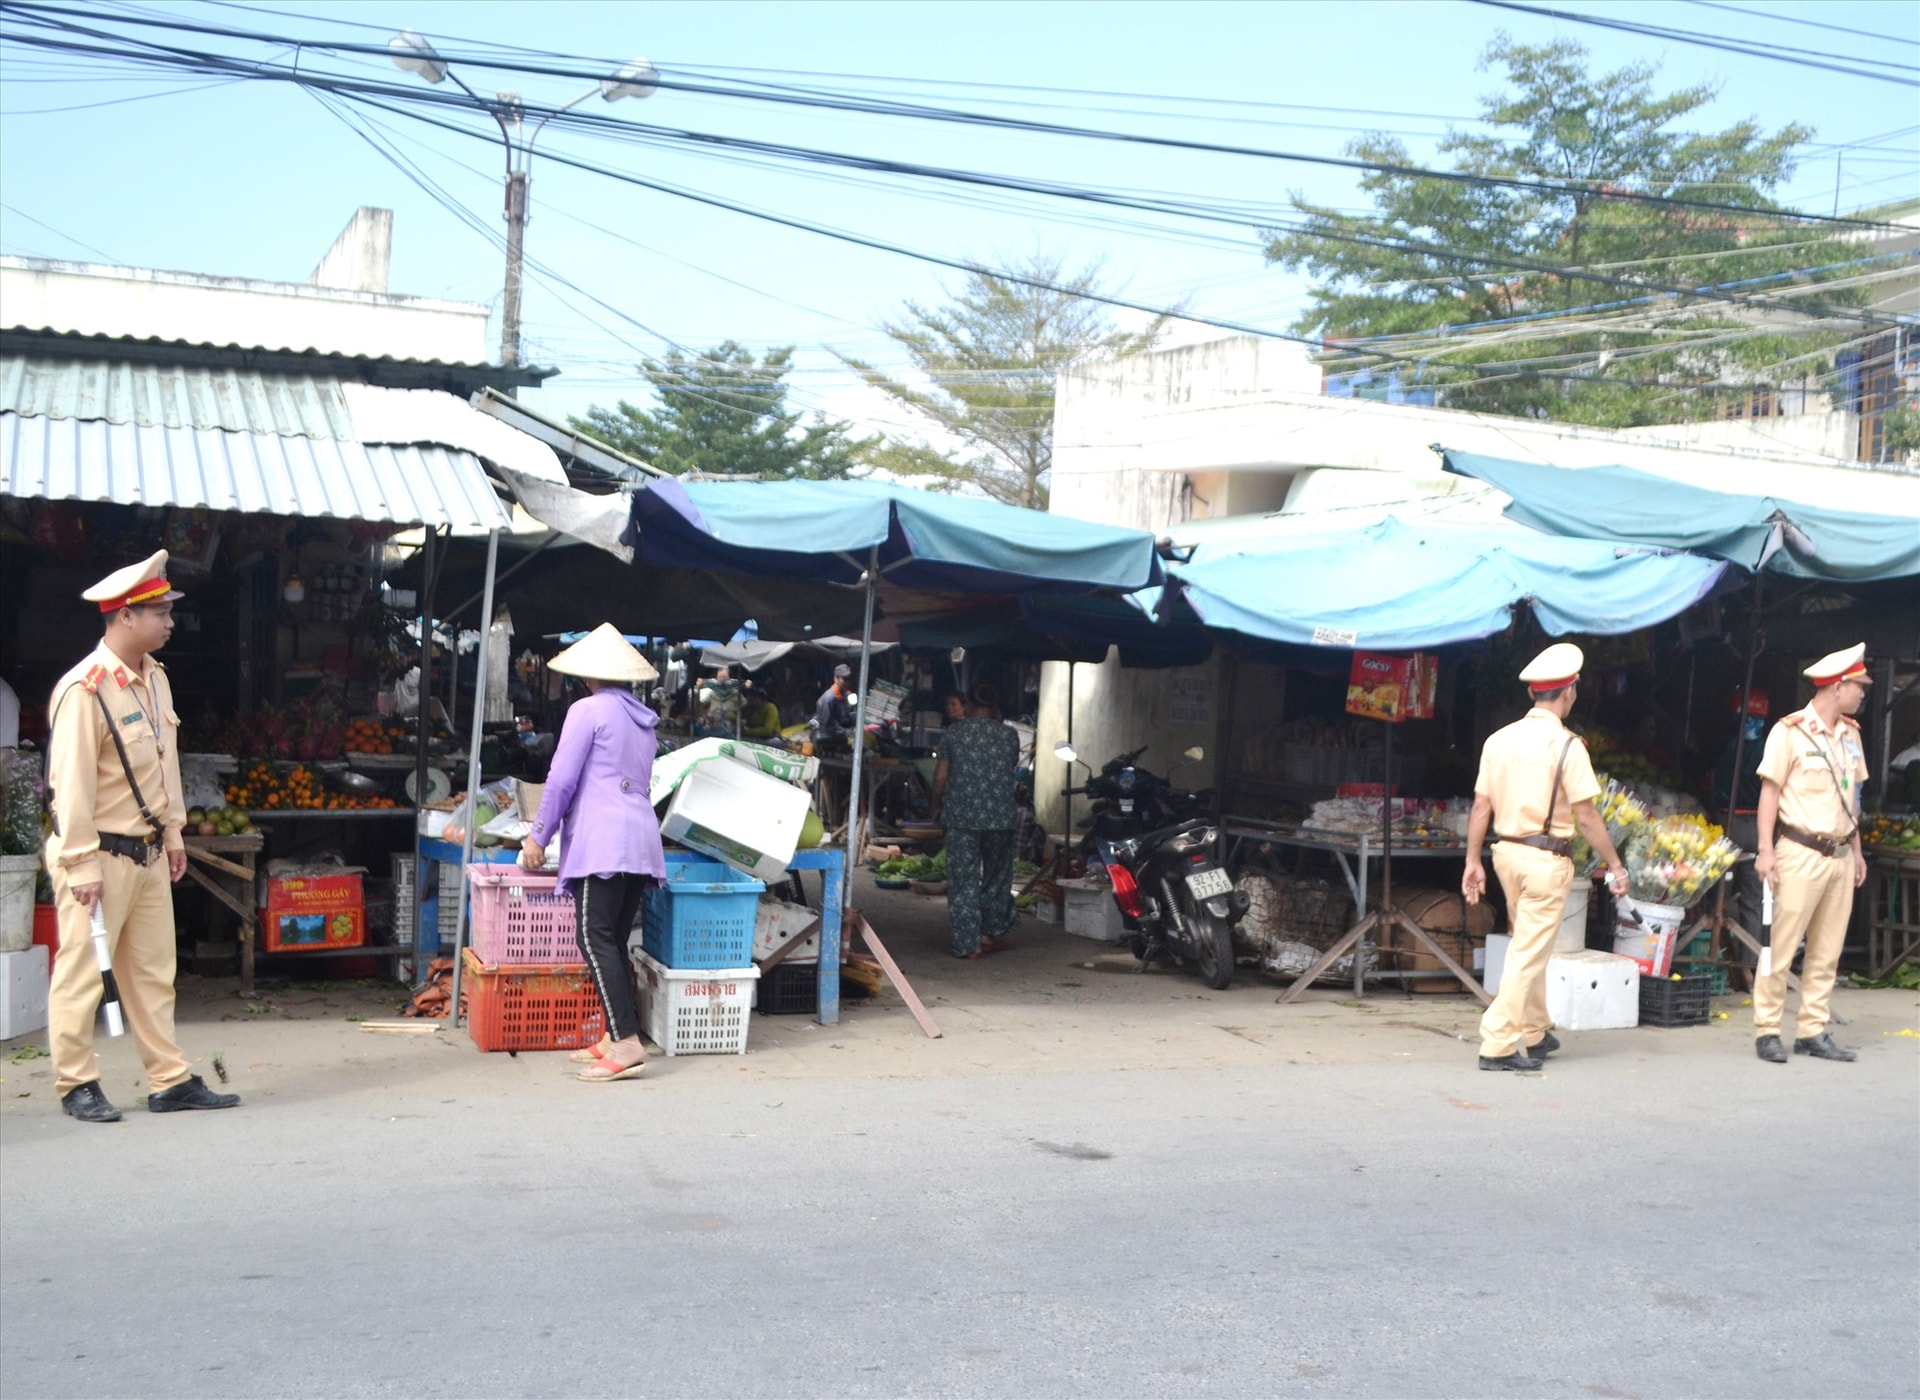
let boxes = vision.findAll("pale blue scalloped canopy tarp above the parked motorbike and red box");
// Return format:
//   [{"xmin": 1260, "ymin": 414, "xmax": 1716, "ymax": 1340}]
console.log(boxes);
[{"xmin": 1162, "ymin": 520, "xmax": 1726, "ymax": 651}]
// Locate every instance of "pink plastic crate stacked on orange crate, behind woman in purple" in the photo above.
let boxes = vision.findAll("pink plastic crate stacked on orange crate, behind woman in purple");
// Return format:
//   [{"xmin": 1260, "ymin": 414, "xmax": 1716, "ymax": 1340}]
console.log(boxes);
[{"xmin": 461, "ymin": 864, "xmax": 607, "ymax": 1050}]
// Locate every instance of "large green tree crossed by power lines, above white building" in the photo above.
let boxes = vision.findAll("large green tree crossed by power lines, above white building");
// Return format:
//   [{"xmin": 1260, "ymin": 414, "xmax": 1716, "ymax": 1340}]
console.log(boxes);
[{"xmin": 1267, "ymin": 35, "xmax": 1860, "ymax": 426}]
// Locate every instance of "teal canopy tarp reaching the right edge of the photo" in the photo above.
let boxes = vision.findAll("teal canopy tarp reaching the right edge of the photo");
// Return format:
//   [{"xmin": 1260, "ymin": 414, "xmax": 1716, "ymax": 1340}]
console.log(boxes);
[{"xmin": 1440, "ymin": 447, "xmax": 1920, "ymax": 582}]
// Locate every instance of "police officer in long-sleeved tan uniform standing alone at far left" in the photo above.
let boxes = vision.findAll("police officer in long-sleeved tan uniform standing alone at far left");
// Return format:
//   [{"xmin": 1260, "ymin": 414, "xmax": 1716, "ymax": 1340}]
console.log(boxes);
[{"xmin": 46, "ymin": 549, "xmax": 240, "ymax": 1123}]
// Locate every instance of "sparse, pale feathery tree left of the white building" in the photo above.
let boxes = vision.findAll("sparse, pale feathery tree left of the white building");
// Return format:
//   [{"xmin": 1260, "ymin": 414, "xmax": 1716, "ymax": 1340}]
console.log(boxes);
[{"xmin": 841, "ymin": 255, "xmax": 1164, "ymax": 509}]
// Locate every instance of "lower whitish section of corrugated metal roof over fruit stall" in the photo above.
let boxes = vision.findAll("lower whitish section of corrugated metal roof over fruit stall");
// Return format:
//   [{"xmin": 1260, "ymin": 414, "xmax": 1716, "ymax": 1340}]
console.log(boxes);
[{"xmin": 0, "ymin": 413, "xmax": 513, "ymax": 534}]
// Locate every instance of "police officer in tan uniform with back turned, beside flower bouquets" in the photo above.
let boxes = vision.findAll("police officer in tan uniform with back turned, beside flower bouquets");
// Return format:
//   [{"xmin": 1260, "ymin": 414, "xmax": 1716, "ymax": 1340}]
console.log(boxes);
[{"xmin": 1459, "ymin": 641, "xmax": 1626, "ymax": 1070}]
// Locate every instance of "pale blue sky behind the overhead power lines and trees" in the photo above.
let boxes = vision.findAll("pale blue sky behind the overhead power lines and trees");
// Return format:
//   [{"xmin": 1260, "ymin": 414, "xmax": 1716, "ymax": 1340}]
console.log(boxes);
[{"xmin": 0, "ymin": 0, "xmax": 1920, "ymax": 438}]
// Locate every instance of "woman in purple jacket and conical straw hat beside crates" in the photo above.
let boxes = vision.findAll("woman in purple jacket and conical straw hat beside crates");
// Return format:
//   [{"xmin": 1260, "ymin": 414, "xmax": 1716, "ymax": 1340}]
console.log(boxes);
[{"xmin": 520, "ymin": 622, "xmax": 666, "ymax": 1083}]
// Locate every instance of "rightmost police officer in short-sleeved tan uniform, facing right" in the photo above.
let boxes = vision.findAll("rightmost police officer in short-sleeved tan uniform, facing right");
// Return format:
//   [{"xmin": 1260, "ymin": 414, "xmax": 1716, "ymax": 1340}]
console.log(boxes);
[{"xmin": 1753, "ymin": 643, "xmax": 1874, "ymax": 1064}]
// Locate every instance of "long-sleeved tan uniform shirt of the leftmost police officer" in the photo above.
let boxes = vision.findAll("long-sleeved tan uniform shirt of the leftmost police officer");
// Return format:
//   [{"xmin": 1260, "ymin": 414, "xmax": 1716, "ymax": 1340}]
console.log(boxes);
[{"xmin": 46, "ymin": 641, "xmax": 186, "ymax": 885}]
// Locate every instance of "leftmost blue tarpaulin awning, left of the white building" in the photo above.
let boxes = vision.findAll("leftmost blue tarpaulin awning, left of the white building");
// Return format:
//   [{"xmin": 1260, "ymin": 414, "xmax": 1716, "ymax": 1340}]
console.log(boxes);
[{"xmin": 626, "ymin": 478, "xmax": 1162, "ymax": 593}]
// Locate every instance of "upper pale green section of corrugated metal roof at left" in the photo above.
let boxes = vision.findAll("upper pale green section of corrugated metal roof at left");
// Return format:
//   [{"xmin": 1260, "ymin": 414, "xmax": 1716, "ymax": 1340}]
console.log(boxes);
[{"xmin": 0, "ymin": 355, "xmax": 353, "ymax": 442}]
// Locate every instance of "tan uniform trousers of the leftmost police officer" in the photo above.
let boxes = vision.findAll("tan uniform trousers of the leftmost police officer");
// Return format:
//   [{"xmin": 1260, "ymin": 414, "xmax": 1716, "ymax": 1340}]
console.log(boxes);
[{"xmin": 46, "ymin": 853, "xmax": 190, "ymax": 1095}]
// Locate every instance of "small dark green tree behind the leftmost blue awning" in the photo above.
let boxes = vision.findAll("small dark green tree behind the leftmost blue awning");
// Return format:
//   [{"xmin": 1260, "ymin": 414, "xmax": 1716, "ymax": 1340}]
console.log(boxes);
[{"xmin": 572, "ymin": 340, "xmax": 881, "ymax": 482}]
